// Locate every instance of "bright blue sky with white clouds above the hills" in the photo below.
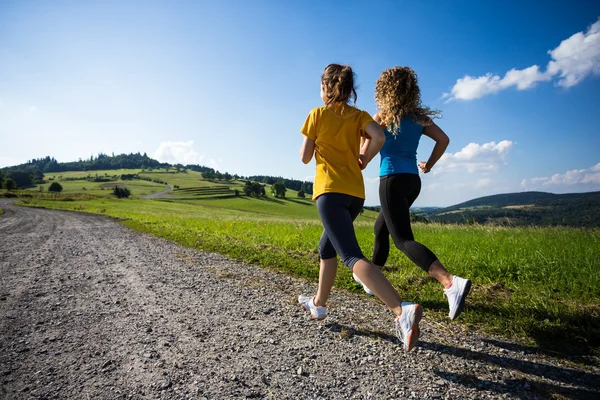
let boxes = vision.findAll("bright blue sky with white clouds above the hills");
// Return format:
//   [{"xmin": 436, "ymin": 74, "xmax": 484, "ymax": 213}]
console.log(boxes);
[{"xmin": 0, "ymin": 0, "xmax": 600, "ymax": 206}]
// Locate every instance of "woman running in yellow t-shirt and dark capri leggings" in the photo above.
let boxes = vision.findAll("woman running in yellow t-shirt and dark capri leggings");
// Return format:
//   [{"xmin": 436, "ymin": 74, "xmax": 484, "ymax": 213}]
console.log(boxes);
[{"xmin": 298, "ymin": 64, "xmax": 423, "ymax": 351}]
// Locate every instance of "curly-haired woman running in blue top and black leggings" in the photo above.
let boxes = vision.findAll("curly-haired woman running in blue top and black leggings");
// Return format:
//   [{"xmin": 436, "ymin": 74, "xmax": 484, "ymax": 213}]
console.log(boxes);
[{"xmin": 355, "ymin": 67, "xmax": 471, "ymax": 319}]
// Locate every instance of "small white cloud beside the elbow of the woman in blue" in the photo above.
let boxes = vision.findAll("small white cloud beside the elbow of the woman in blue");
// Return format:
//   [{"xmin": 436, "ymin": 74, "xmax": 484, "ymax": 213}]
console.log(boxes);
[{"xmin": 432, "ymin": 140, "xmax": 514, "ymax": 174}]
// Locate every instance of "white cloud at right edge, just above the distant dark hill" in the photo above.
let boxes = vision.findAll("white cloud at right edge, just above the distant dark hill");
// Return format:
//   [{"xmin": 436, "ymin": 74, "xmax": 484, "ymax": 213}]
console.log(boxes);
[{"xmin": 521, "ymin": 163, "xmax": 600, "ymax": 191}]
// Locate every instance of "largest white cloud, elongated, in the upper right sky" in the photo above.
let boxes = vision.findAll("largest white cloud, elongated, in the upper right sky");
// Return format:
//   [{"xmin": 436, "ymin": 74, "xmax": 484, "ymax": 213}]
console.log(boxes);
[{"xmin": 442, "ymin": 18, "xmax": 600, "ymax": 102}]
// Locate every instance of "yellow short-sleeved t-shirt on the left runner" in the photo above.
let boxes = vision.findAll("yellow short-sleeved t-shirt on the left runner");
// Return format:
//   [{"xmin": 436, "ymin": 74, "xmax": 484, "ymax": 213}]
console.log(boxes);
[{"xmin": 300, "ymin": 106, "xmax": 373, "ymax": 200}]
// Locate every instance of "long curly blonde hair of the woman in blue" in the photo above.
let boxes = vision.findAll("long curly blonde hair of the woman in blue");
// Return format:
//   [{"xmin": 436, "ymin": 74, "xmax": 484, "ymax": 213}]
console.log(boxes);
[{"xmin": 375, "ymin": 66, "xmax": 441, "ymax": 134}]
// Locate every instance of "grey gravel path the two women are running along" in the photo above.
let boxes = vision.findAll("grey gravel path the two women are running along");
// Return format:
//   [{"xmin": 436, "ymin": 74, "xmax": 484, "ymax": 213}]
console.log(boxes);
[{"xmin": 0, "ymin": 200, "xmax": 600, "ymax": 399}]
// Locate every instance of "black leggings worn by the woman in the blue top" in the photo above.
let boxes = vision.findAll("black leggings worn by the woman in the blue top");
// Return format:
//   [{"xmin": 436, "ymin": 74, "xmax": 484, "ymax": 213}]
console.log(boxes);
[{"xmin": 373, "ymin": 174, "xmax": 437, "ymax": 272}]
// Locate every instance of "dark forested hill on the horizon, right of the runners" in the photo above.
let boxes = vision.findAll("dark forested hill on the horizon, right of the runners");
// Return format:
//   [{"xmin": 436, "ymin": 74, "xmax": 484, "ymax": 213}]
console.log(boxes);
[{"xmin": 420, "ymin": 192, "xmax": 600, "ymax": 228}]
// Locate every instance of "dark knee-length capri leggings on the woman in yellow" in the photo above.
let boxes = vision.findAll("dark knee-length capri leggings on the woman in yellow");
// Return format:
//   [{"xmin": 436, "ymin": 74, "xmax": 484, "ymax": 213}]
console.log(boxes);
[{"xmin": 317, "ymin": 193, "xmax": 365, "ymax": 269}]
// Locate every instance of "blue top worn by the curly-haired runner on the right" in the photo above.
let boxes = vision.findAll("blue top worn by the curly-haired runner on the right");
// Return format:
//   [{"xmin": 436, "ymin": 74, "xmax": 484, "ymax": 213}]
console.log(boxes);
[{"xmin": 379, "ymin": 116, "xmax": 423, "ymax": 176}]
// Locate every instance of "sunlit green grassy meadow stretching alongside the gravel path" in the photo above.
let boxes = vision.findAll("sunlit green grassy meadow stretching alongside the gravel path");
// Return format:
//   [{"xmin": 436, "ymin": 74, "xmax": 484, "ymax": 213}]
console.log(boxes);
[{"xmin": 9, "ymin": 171, "xmax": 600, "ymax": 362}]
